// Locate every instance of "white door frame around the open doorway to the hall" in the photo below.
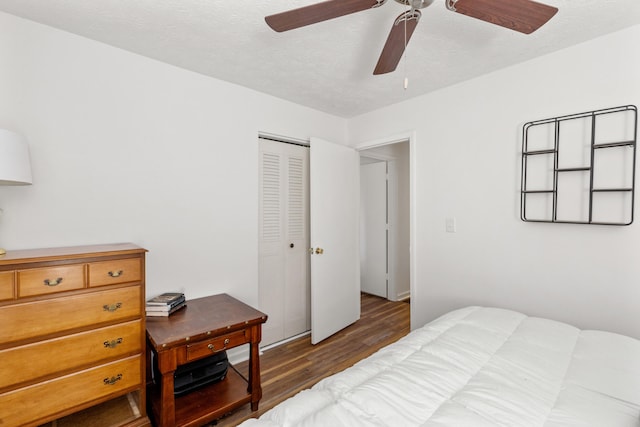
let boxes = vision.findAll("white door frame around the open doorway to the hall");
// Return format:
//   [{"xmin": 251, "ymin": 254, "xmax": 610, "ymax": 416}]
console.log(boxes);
[{"xmin": 354, "ymin": 130, "xmax": 417, "ymax": 325}]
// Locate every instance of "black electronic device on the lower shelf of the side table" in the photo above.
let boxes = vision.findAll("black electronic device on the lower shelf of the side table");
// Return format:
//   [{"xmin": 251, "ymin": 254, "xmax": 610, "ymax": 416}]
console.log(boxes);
[{"xmin": 152, "ymin": 351, "xmax": 229, "ymax": 396}]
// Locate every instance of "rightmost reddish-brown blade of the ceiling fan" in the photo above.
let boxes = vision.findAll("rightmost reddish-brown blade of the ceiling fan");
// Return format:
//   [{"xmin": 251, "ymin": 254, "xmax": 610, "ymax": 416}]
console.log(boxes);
[{"xmin": 447, "ymin": 0, "xmax": 558, "ymax": 34}]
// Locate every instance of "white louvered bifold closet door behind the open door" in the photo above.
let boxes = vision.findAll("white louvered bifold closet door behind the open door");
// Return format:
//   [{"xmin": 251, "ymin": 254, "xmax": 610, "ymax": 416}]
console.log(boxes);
[{"xmin": 259, "ymin": 139, "xmax": 311, "ymax": 346}]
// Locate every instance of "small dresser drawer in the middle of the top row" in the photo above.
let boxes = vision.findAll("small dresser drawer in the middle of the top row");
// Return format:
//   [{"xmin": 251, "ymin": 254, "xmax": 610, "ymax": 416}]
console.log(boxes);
[{"xmin": 18, "ymin": 264, "xmax": 85, "ymax": 297}]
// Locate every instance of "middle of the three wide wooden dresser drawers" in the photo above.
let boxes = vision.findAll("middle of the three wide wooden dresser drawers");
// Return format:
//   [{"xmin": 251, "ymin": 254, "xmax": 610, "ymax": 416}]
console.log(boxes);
[{"xmin": 0, "ymin": 320, "xmax": 142, "ymax": 390}]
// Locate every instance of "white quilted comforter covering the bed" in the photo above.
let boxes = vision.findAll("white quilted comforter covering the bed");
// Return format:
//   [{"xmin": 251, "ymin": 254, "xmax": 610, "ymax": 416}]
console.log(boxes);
[{"xmin": 242, "ymin": 307, "xmax": 640, "ymax": 427}]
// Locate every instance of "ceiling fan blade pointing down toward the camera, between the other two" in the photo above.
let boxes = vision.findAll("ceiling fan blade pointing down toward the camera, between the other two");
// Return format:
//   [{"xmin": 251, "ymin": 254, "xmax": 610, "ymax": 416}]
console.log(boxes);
[{"xmin": 373, "ymin": 10, "xmax": 421, "ymax": 75}]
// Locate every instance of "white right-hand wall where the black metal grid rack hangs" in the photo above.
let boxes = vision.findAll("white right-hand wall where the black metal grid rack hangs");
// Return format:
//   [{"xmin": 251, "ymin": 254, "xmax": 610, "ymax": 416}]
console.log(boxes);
[{"xmin": 349, "ymin": 26, "xmax": 640, "ymax": 337}]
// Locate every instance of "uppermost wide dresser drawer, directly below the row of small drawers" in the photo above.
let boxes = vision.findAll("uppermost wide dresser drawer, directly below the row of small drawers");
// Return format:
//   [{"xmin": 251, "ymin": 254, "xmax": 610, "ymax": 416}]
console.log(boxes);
[{"xmin": 0, "ymin": 286, "xmax": 142, "ymax": 344}]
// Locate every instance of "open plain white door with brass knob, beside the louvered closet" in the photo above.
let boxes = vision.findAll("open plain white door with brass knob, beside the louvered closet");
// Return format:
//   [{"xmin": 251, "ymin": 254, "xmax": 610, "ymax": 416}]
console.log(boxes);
[{"xmin": 309, "ymin": 138, "xmax": 360, "ymax": 344}]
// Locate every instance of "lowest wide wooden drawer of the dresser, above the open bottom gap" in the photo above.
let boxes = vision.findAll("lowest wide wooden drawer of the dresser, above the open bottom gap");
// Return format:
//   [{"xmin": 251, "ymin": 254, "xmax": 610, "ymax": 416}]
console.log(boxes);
[{"xmin": 0, "ymin": 356, "xmax": 142, "ymax": 426}]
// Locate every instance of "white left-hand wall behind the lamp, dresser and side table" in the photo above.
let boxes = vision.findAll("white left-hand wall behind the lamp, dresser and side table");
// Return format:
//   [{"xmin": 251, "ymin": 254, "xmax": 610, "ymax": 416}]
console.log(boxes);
[{"xmin": 0, "ymin": 13, "xmax": 346, "ymax": 310}]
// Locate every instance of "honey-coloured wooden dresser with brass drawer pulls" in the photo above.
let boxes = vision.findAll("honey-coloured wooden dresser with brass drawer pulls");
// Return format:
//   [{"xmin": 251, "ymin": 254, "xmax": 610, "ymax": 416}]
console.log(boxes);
[{"xmin": 0, "ymin": 243, "xmax": 150, "ymax": 427}]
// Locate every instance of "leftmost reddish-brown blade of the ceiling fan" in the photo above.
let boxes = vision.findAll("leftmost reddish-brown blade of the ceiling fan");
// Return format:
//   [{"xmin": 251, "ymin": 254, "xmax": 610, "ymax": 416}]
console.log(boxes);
[{"xmin": 264, "ymin": 0, "xmax": 386, "ymax": 32}]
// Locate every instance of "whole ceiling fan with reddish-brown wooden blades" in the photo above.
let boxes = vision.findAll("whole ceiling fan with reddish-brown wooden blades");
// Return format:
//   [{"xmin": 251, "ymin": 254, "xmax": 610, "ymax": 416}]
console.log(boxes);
[{"xmin": 265, "ymin": 0, "xmax": 558, "ymax": 74}]
